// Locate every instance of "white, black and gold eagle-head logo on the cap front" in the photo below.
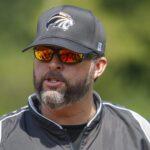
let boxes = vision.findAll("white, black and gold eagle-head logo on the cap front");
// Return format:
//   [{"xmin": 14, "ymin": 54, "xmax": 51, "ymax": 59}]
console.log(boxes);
[{"xmin": 46, "ymin": 12, "xmax": 74, "ymax": 31}]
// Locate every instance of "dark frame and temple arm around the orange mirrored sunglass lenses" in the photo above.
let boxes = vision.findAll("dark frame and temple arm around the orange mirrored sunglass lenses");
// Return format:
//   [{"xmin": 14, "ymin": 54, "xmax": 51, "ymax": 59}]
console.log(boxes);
[{"xmin": 33, "ymin": 46, "xmax": 99, "ymax": 65}]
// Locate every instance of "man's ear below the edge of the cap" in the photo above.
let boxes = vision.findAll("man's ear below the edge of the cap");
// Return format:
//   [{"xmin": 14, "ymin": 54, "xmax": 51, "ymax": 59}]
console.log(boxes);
[{"xmin": 94, "ymin": 57, "xmax": 107, "ymax": 80}]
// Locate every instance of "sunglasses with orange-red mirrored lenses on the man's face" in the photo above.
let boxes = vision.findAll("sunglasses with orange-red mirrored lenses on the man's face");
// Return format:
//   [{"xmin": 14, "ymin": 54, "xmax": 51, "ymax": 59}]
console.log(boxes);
[{"xmin": 34, "ymin": 46, "xmax": 98, "ymax": 64}]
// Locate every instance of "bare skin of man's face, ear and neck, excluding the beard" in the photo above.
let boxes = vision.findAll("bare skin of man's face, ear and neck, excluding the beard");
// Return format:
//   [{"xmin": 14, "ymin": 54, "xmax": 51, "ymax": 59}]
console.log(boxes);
[{"xmin": 34, "ymin": 52, "xmax": 107, "ymax": 125}]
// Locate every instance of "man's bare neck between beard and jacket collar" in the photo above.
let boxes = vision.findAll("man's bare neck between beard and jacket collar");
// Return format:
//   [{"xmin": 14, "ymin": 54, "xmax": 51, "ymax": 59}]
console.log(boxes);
[{"xmin": 41, "ymin": 93, "xmax": 96, "ymax": 125}]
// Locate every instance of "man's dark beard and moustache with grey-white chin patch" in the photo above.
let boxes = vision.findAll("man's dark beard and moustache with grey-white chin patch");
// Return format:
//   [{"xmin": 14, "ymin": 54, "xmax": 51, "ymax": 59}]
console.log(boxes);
[{"xmin": 33, "ymin": 65, "xmax": 94, "ymax": 109}]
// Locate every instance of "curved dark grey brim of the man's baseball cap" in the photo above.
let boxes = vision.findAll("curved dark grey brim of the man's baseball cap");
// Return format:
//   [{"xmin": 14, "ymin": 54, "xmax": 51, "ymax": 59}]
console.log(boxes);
[{"xmin": 22, "ymin": 37, "xmax": 92, "ymax": 53}]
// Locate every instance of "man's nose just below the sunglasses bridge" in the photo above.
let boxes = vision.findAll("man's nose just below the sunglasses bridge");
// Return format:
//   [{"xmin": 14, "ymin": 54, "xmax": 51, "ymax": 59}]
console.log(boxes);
[{"xmin": 49, "ymin": 54, "xmax": 63, "ymax": 70}]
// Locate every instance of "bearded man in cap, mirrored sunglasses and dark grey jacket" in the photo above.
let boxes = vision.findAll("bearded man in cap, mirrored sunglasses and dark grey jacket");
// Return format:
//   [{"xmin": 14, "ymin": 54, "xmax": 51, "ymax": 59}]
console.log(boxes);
[{"xmin": 0, "ymin": 5, "xmax": 150, "ymax": 150}]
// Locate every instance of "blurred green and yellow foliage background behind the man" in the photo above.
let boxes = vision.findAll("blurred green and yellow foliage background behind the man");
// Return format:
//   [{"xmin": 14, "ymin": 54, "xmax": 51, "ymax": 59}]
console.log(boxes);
[{"xmin": 0, "ymin": 0, "xmax": 150, "ymax": 119}]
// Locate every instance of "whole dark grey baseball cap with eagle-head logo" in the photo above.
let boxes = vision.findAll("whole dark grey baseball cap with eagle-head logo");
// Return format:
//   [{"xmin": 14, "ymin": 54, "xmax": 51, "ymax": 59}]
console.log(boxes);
[{"xmin": 22, "ymin": 5, "xmax": 106, "ymax": 55}]
